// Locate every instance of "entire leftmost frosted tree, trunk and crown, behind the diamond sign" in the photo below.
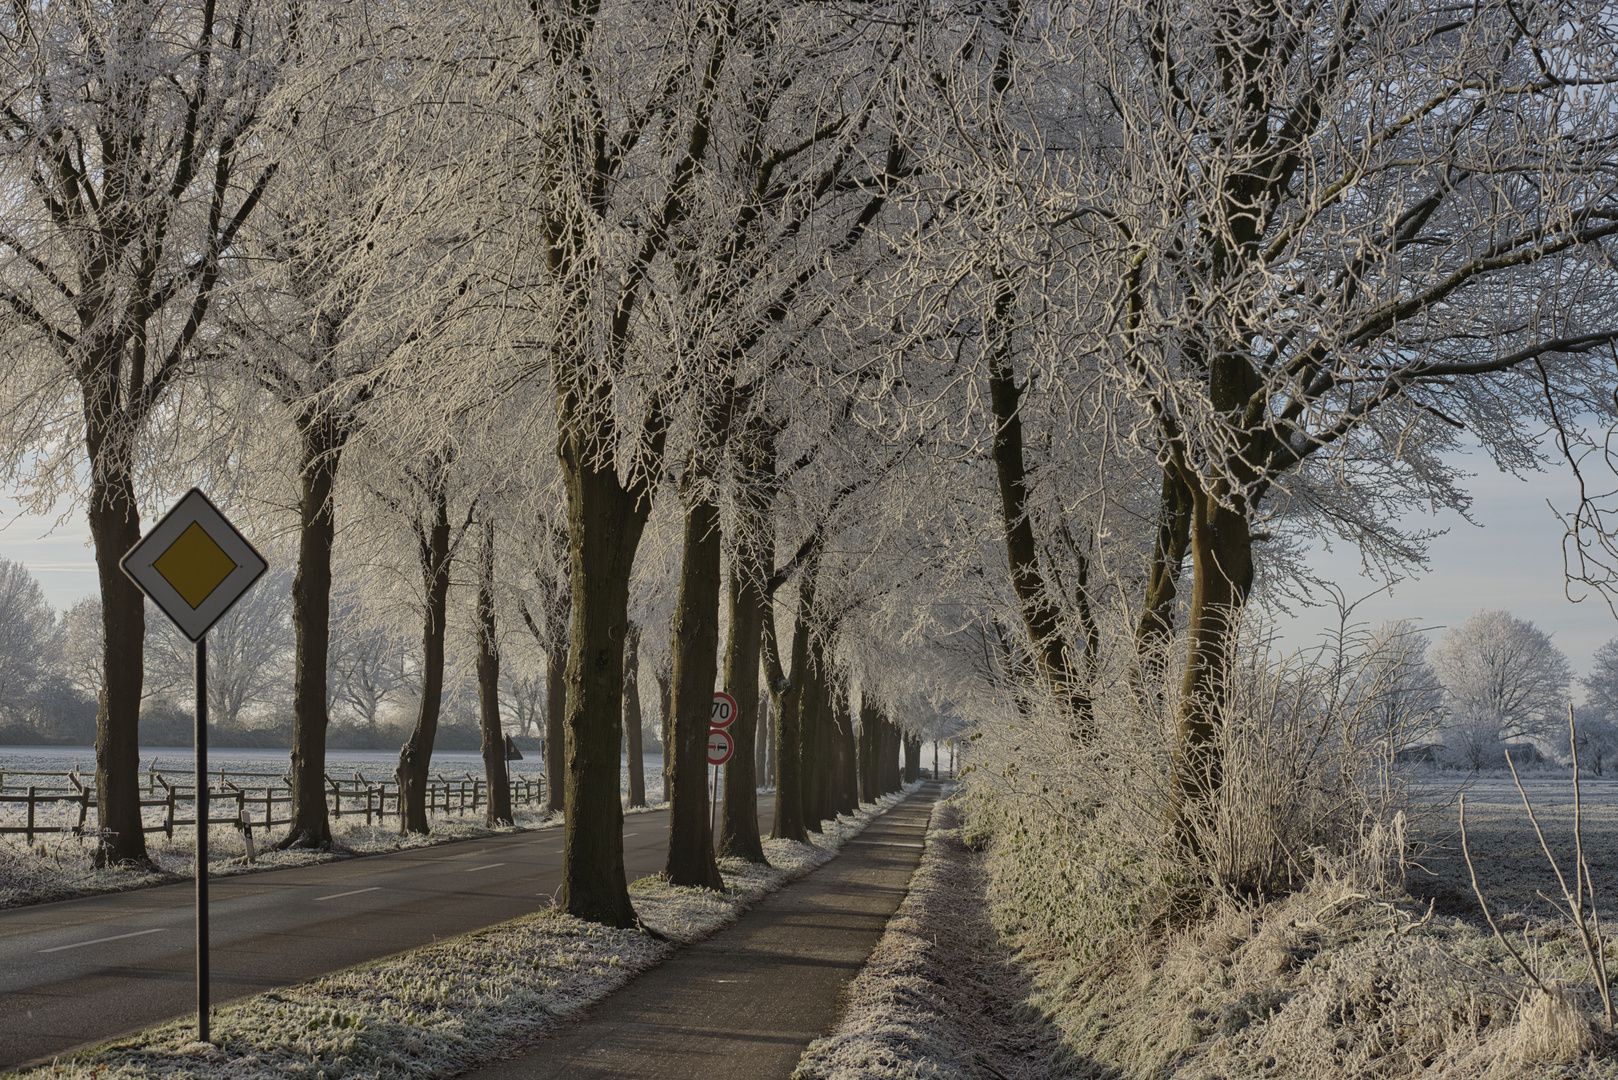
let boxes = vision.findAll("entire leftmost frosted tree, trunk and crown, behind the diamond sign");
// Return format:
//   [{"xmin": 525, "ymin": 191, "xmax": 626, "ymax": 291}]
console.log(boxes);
[{"xmin": 0, "ymin": 0, "xmax": 278, "ymax": 863}]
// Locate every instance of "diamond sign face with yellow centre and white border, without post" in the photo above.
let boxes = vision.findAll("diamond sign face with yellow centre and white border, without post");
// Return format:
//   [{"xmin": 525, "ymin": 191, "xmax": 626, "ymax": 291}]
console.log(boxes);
[{"xmin": 123, "ymin": 487, "xmax": 269, "ymax": 641}]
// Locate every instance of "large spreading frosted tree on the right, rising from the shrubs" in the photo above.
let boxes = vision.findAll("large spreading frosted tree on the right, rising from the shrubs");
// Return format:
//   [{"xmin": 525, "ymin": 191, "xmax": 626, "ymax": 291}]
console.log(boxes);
[{"xmin": 937, "ymin": 0, "xmax": 1618, "ymax": 850}]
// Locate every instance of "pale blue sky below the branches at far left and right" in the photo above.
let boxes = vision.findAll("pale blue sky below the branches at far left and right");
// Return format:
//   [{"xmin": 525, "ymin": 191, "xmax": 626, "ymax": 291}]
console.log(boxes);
[{"xmin": 0, "ymin": 443, "xmax": 1618, "ymax": 689}]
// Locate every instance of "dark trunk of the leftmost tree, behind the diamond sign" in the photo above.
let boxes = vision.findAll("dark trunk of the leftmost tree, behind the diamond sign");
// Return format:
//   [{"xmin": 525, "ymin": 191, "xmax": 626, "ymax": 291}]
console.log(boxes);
[{"xmin": 89, "ymin": 466, "xmax": 150, "ymax": 865}]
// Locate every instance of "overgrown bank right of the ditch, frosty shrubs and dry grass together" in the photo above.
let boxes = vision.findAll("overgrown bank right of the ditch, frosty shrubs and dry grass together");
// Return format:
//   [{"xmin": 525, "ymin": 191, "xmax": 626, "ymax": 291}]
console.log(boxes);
[{"xmin": 961, "ymin": 612, "xmax": 1618, "ymax": 1080}]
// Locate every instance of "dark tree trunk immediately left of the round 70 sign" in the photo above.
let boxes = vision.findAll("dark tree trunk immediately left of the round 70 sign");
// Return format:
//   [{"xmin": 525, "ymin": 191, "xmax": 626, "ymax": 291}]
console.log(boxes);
[{"xmin": 663, "ymin": 495, "xmax": 735, "ymax": 891}]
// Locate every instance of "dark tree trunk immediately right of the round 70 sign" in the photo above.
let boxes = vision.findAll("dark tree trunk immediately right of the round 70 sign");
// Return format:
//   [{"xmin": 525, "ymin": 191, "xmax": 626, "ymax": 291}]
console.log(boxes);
[{"xmin": 718, "ymin": 523, "xmax": 767, "ymax": 863}]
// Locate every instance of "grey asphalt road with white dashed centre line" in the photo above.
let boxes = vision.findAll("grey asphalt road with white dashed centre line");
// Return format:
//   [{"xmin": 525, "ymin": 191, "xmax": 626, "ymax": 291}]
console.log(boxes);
[{"xmin": 0, "ymin": 795, "xmax": 775, "ymax": 1070}]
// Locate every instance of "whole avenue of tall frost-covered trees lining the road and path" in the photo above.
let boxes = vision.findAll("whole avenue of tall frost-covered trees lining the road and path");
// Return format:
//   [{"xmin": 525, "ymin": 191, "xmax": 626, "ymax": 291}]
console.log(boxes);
[{"xmin": 0, "ymin": 0, "xmax": 1618, "ymax": 925}]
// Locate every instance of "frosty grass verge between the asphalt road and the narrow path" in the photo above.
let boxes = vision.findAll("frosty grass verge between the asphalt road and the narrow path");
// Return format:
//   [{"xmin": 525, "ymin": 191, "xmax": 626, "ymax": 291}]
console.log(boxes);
[{"xmin": 8, "ymin": 795, "xmax": 903, "ymax": 1080}]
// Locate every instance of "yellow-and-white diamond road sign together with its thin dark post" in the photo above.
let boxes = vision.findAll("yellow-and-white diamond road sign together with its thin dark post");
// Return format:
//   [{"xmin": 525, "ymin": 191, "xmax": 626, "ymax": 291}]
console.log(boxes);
[{"xmin": 120, "ymin": 487, "xmax": 269, "ymax": 1043}]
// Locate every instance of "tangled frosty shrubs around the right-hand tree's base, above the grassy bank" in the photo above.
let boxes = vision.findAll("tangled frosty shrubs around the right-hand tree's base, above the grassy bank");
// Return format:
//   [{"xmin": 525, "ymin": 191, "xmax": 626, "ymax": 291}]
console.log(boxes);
[{"xmin": 963, "ymin": 608, "xmax": 1437, "ymax": 957}]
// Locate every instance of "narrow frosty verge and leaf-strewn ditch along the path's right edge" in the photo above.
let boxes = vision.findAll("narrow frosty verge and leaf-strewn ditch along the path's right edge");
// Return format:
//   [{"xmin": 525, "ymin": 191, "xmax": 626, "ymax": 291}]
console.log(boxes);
[{"xmin": 793, "ymin": 801, "xmax": 1082, "ymax": 1080}]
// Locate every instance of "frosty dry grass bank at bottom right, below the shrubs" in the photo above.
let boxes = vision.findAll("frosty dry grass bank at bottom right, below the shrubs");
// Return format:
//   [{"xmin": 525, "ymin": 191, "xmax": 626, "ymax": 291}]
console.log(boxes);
[{"xmin": 957, "ymin": 792, "xmax": 1618, "ymax": 1080}]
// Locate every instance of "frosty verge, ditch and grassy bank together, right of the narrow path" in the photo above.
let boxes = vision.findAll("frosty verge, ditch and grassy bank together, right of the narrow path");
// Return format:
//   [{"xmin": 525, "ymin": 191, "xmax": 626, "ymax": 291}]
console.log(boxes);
[{"xmin": 794, "ymin": 780, "xmax": 1618, "ymax": 1080}]
